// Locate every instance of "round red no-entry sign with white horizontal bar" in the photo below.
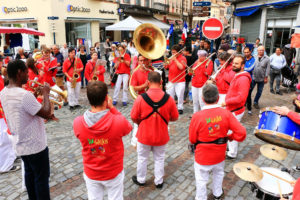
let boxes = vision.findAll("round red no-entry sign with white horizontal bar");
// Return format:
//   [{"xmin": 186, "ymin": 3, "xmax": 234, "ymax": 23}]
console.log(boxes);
[{"xmin": 202, "ymin": 18, "xmax": 224, "ymax": 40}]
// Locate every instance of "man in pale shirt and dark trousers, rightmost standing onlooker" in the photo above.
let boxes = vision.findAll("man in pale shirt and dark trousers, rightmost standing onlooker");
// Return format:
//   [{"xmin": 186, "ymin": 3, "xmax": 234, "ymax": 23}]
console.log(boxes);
[{"xmin": 270, "ymin": 48, "xmax": 286, "ymax": 95}]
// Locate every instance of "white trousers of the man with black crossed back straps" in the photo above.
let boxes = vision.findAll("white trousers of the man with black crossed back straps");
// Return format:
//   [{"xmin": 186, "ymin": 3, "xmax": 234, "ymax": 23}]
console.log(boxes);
[{"xmin": 136, "ymin": 142, "xmax": 166, "ymax": 185}]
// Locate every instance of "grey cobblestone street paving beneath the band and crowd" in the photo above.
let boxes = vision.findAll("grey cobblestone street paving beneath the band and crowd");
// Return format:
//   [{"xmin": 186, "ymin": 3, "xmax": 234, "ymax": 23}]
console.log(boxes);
[{"xmin": 0, "ymin": 80, "xmax": 300, "ymax": 200}]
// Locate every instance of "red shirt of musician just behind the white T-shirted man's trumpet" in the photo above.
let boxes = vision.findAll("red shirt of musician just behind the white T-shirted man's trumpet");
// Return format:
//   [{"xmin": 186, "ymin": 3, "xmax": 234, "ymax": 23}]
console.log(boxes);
[{"xmin": 36, "ymin": 56, "xmax": 57, "ymax": 87}]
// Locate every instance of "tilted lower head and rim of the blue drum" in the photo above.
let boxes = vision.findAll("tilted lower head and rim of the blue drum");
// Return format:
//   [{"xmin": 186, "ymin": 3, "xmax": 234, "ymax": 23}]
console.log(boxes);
[{"xmin": 255, "ymin": 130, "xmax": 300, "ymax": 151}]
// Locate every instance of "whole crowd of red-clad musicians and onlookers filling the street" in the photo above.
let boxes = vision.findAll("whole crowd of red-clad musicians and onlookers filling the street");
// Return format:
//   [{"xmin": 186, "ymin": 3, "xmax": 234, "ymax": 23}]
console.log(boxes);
[{"xmin": 0, "ymin": 34, "xmax": 300, "ymax": 200}]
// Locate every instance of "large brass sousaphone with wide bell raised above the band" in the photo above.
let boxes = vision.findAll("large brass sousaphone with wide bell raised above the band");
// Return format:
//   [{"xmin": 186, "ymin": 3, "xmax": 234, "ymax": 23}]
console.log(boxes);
[{"xmin": 129, "ymin": 23, "xmax": 167, "ymax": 99}]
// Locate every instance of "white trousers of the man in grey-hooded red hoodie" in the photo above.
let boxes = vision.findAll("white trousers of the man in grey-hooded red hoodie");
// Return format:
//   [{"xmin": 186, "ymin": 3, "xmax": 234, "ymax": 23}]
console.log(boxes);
[{"xmin": 83, "ymin": 170, "xmax": 124, "ymax": 200}]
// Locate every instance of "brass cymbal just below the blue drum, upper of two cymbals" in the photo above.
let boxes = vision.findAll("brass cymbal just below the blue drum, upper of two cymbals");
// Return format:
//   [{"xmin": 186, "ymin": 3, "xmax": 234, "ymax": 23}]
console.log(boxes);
[{"xmin": 260, "ymin": 144, "xmax": 287, "ymax": 160}]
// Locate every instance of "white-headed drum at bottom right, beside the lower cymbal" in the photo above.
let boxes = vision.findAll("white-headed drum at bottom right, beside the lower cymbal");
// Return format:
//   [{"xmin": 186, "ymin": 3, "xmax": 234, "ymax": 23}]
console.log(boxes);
[{"xmin": 250, "ymin": 167, "xmax": 295, "ymax": 200}]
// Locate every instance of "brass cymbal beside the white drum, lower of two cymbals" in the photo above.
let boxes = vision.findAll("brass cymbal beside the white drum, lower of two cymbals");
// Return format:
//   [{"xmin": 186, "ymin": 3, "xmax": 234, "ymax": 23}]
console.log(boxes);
[{"xmin": 233, "ymin": 162, "xmax": 263, "ymax": 182}]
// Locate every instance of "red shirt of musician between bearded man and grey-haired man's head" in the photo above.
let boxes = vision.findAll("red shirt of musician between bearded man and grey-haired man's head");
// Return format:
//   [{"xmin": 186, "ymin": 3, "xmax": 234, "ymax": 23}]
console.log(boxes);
[{"xmin": 216, "ymin": 63, "xmax": 235, "ymax": 94}]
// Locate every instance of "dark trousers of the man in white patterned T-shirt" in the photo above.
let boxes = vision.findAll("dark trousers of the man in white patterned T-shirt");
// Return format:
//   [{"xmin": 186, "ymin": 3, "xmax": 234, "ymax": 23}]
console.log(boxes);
[{"xmin": 21, "ymin": 147, "xmax": 50, "ymax": 200}]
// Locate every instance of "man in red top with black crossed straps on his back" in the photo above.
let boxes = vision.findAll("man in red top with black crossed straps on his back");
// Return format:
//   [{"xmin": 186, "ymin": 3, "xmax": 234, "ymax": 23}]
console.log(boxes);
[{"xmin": 131, "ymin": 72, "xmax": 178, "ymax": 189}]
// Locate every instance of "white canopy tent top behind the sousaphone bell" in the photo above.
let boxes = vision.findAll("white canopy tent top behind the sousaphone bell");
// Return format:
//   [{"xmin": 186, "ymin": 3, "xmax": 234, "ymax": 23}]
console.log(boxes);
[{"xmin": 105, "ymin": 16, "xmax": 170, "ymax": 31}]
